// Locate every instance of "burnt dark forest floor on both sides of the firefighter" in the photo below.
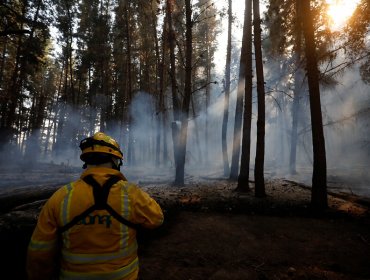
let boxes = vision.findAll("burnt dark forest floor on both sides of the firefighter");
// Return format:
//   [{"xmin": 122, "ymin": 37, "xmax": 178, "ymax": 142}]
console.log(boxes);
[{"xmin": 0, "ymin": 165, "xmax": 370, "ymax": 280}]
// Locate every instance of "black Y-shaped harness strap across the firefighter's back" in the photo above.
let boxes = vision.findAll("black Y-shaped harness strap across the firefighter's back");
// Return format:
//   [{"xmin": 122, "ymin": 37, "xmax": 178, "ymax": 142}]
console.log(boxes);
[{"xmin": 59, "ymin": 175, "xmax": 138, "ymax": 233}]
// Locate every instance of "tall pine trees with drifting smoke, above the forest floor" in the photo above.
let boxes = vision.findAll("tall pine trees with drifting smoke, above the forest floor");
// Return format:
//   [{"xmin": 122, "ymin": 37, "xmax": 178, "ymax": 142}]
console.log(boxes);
[{"xmin": 0, "ymin": 0, "xmax": 370, "ymax": 204}]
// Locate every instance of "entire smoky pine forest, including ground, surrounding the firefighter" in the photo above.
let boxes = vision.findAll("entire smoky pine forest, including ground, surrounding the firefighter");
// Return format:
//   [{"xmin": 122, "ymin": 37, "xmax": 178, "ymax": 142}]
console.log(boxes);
[{"xmin": 0, "ymin": 0, "xmax": 370, "ymax": 280}]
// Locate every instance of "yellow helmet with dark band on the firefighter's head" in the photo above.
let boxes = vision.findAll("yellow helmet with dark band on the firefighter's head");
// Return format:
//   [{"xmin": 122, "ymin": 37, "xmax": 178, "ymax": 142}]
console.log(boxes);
[{"xmin": 80, "ymin": 132, "xmax": 123, "ymax": 161}]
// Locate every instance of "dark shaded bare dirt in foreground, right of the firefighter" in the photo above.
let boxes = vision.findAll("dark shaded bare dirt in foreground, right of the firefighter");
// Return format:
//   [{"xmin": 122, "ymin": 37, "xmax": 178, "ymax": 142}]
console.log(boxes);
[{"xmin": 140, "ymin": 212, "xmax": 370, "ymax": 280}]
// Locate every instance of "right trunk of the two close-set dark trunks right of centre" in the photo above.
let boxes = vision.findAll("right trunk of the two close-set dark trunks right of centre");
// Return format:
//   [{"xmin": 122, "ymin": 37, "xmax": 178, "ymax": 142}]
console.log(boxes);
[{"xmin": 253, "ymin": 0, "xmax": 266, "ymax": 197}]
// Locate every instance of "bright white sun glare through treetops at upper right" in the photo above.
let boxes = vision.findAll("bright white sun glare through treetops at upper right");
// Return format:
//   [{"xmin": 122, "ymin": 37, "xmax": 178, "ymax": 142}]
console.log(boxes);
[{"xmin": 326, "ymin": 0, "xmax": 360, "ymax": 30}]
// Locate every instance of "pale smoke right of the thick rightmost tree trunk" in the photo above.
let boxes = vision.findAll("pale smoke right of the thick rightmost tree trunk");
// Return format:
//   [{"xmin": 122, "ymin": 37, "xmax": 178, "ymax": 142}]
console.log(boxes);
[{"xmin": 322, "ymin": 68, "xmax": 370, "ymax": 188}]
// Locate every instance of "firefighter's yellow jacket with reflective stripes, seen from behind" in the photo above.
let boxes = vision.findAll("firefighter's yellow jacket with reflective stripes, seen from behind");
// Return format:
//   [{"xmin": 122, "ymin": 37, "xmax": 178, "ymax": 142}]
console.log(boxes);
[{"xmin": 27, "ymin": 167, "xmax": 163, "ymax": 280}]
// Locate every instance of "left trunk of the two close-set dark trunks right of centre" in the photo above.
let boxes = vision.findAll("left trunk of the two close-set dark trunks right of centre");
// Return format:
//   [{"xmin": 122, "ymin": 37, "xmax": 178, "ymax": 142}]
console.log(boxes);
[{"xmin": 236, "ymin": 0, "xmax": 253, "ymax": 191}]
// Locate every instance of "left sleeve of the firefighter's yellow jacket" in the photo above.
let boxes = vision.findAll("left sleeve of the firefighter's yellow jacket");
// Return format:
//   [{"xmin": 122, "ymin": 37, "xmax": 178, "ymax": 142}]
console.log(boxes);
[{"xmin": 26, "ymin": 188, "xmax": 60, "ymax": 280}]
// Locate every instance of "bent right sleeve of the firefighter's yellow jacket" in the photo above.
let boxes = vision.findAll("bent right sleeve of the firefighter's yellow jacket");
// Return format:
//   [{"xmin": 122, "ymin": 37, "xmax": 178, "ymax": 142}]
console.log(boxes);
[{"xmin": 132, "ymin": 186, "xmax": 163, "ymax": 229}]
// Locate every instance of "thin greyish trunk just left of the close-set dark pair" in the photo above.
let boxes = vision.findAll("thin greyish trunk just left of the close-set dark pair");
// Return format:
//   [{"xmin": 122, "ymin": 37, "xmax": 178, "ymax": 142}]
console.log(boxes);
[{"xmin": 221, "ymin": 0, "xmax": 233, "ymax": 176}]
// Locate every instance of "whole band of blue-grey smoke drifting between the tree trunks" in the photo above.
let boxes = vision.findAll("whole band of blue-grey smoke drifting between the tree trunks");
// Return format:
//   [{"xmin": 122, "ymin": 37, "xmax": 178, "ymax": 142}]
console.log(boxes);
[{"xmin": 2, "ymin": 53, "xmax": 370, "ymax": 195}]
